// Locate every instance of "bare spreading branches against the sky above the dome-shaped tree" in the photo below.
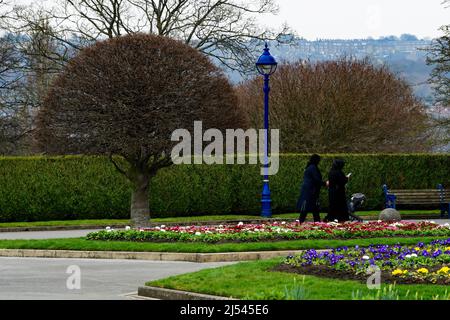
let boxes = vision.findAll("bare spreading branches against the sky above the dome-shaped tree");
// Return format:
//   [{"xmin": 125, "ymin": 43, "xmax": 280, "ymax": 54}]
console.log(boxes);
[{"xmin": 4, "ymin": 0, "xmax": 288, "ymax": 72}]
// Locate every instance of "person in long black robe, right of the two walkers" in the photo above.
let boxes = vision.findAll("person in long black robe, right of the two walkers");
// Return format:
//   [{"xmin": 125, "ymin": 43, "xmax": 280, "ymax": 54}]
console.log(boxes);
[{"xmin": 325, "ymin": 159, "xmax": 350, "ymax": 222}]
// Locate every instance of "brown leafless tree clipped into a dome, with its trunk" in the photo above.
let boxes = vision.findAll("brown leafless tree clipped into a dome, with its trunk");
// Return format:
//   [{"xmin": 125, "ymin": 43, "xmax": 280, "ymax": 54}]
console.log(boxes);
[{"xmin": 37, "ymin": 34, "xmax": 242, "ymax": 226}]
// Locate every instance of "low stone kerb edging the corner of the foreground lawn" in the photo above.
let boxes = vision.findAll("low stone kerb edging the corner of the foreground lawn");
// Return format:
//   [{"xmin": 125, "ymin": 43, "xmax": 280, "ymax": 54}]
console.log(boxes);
[{"xmin": 138, "ymin": 286, "xmax": 237, "ymax": 300}]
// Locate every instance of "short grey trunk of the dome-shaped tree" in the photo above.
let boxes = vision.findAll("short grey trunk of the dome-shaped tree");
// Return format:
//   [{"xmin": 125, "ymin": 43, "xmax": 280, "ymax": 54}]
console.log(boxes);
[{"xmin": 131, "ymin": 174, "xmax": 150, "ymax": 228}]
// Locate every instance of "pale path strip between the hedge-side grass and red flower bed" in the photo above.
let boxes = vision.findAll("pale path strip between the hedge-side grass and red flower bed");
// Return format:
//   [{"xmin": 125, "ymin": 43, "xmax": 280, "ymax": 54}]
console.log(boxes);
[{"xmin": 0, "ymin": 219, "xmax": 450, "ymax": 240}]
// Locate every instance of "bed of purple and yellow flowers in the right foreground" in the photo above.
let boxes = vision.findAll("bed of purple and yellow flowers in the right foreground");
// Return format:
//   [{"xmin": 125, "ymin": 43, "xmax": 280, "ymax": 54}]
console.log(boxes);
[{"xmin": 275, "ymin": 238, "xmax": 450, "ymax": 285}]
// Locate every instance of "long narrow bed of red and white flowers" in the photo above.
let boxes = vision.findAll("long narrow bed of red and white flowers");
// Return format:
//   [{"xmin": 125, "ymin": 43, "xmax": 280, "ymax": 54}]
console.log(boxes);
[{"xmin": 87, "ymin": 222, "xmax": 450, "ymax": 243}]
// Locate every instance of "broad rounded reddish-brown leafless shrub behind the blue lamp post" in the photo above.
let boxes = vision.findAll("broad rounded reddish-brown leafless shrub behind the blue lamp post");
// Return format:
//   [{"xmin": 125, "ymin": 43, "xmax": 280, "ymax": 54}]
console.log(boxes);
[{"xmin": 238, "ymin": 59, "xmax": 428, "ymax": 153}]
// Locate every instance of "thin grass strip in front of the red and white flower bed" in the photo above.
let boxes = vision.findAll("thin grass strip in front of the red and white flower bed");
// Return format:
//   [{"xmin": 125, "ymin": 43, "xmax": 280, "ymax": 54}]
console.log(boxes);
[{"xmin": 0, "ymin": 237, "xmax": 447, "ymax": 253}]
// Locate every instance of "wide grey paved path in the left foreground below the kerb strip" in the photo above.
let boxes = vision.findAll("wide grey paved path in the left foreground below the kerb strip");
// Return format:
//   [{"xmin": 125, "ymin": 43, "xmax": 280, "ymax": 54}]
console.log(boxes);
[{"xmin": 0, "ymin": 258, "xmax": 230, "ymax": 300}]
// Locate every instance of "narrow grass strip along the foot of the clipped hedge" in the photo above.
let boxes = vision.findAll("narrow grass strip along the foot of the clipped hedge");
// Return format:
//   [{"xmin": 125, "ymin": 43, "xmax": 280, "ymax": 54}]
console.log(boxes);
[{"xmin": 0, "ymin": 210, "xmax": 440, "ymax": 228}]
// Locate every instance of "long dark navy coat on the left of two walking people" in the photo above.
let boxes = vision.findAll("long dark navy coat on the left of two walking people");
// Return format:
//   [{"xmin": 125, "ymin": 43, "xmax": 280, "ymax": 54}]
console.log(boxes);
[{"xmin": 297, "ymin": 164, "xmax": 325, "ymax": 212}]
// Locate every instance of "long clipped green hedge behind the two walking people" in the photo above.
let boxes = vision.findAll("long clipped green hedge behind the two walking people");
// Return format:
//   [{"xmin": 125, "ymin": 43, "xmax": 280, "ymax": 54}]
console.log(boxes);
[{"xmin": 0, "ymin": 154, "xmax": 450, "ymax": 222}]
